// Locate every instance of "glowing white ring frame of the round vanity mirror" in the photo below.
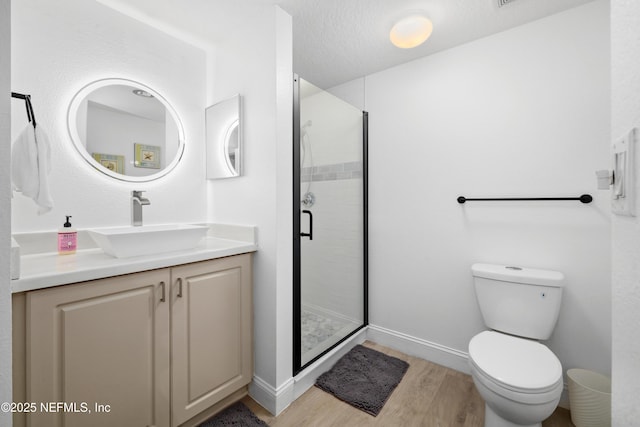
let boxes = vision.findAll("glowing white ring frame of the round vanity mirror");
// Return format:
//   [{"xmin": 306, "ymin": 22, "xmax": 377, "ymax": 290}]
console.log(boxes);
[{"xmin": 67, "ymin": 78, "xmax": 185, "ymax": 182}]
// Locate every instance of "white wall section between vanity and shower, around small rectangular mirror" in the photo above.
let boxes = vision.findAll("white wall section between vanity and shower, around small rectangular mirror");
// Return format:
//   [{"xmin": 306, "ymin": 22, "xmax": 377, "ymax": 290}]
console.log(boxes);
[{"xmin": 207, "ymin": 4, "xmax": 293, "ymax": 412}]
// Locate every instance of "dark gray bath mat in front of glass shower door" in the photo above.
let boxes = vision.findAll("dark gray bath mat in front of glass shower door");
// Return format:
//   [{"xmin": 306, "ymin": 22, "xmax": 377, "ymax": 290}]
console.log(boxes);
[{"xmin": 316, "ymin": 345, "xmax": 409, "ymax": 417}]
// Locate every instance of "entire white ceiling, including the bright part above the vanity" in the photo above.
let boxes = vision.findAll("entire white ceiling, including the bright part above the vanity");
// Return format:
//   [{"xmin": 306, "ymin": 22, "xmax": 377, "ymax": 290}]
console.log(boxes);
[{"xmin": 98, "ymin": 0, "xmax": 592, "ymax": 88}]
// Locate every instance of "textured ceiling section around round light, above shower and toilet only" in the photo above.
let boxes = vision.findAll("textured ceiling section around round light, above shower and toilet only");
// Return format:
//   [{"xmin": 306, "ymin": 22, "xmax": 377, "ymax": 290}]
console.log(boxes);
[{"xmin": 279, "ymin": 0, "xmax": 590, "ymax": 88}]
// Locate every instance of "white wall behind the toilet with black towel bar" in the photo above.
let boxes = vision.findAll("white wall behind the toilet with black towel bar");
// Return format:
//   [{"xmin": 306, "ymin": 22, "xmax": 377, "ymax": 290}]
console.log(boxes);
[{"xmin": 366, "ymin": 0, "xmax": 608, "ymax": 384}]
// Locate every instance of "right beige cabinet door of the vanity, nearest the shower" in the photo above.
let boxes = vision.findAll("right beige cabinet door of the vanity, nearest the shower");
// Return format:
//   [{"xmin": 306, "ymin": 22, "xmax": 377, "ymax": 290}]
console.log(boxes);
[{"xmin": 171, "ymin": 254, "xmax": 253, "ymax": 426}]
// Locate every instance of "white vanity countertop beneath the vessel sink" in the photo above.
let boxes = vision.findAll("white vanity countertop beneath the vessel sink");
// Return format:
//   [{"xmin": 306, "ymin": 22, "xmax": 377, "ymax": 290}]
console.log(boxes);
[{"xmin": 11, "ymin": 226, "xmax": 258, "ymax": 293}]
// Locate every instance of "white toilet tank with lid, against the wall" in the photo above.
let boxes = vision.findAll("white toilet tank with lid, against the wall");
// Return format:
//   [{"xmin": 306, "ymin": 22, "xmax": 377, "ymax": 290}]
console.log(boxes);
[{"xmin": 471, "ymin": 264, "xmax": 564, "ymax": 340}]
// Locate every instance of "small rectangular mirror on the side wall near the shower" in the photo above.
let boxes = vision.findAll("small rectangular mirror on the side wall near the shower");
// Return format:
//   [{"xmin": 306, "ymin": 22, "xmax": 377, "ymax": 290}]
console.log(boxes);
[{"xmin": 206, "ymin": 95, "xmax": 242, "ymax": 179}]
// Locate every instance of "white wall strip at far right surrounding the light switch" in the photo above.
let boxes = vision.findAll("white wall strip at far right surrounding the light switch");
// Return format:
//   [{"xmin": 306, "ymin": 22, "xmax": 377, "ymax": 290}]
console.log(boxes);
[{"xmin": 611, "ymin": 0, "xmax": 640, "ymax": 427}]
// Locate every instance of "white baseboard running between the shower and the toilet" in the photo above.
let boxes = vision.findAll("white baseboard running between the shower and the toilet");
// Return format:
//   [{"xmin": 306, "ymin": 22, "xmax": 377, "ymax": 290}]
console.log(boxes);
[{"xmin": 367, "ymin": 325, "xmax": 471, "ymax": 374}]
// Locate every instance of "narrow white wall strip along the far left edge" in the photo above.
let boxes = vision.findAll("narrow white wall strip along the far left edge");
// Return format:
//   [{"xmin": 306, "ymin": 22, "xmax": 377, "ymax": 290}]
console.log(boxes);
[{"xmin": 0, "ymin": 0, "xmax": 11, "ymax": 426}]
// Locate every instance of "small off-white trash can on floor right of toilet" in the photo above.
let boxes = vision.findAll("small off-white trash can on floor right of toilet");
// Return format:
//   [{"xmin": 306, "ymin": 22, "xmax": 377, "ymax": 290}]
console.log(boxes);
[{"xmin": 567, "ymin": 369, "xmax": 611, "ymax": 427}]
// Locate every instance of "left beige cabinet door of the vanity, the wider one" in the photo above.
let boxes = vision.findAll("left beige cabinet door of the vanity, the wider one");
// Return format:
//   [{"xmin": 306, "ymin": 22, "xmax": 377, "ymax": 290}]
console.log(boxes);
[{"xmin": 27, "ymin": 269, "xmax": 170, "ymax": 427}]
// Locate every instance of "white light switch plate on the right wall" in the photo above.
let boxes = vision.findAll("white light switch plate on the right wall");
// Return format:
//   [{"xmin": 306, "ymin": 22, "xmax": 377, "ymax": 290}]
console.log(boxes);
[{"xmin": 611, "ymin": 128, "xmax": 638, "ymax": 216}]
